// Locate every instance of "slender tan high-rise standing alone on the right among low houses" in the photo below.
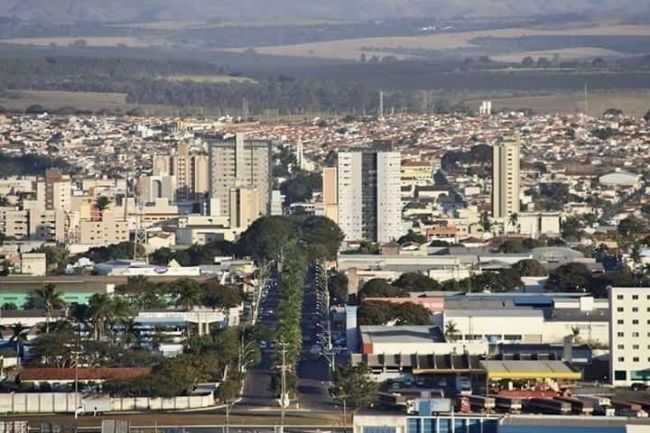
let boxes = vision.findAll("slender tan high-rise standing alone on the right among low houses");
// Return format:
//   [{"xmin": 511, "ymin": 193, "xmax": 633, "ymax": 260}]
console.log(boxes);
[{"xmin": 492, "ymin": 137, "xmax": 521, "ymax": 221}]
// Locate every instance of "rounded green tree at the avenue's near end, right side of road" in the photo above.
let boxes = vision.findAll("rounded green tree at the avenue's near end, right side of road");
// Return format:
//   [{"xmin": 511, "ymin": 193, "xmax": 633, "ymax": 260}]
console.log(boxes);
[{"xmin": 330, "ymin": 364, "xmax": 379, "ymax": 412}]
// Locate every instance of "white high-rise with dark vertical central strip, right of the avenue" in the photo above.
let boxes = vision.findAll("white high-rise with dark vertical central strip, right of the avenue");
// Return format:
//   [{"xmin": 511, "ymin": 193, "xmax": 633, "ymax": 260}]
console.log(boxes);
[{"xmin": 337, "ymin": 152, "xmax": 403, "ymax": 243}]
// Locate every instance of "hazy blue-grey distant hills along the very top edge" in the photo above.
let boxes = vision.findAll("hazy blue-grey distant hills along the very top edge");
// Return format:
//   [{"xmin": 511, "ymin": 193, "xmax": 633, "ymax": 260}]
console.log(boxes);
[{"xmin": 0, "ymin": 0, "xmax": 650, "ymax": 23}]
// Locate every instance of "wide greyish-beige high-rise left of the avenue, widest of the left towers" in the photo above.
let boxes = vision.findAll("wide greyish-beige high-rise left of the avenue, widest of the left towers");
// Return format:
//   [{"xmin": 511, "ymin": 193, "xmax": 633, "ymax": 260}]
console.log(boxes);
[{"xmin": 210, "ymin": 134, "xmax": 272, "ymax": 226}]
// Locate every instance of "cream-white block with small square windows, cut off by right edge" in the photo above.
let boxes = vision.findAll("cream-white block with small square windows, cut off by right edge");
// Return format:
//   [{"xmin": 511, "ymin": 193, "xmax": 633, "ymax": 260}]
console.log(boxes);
[{"xmin": 609, "ymin": 287, "xmax": 650, "ymax": 386}]
